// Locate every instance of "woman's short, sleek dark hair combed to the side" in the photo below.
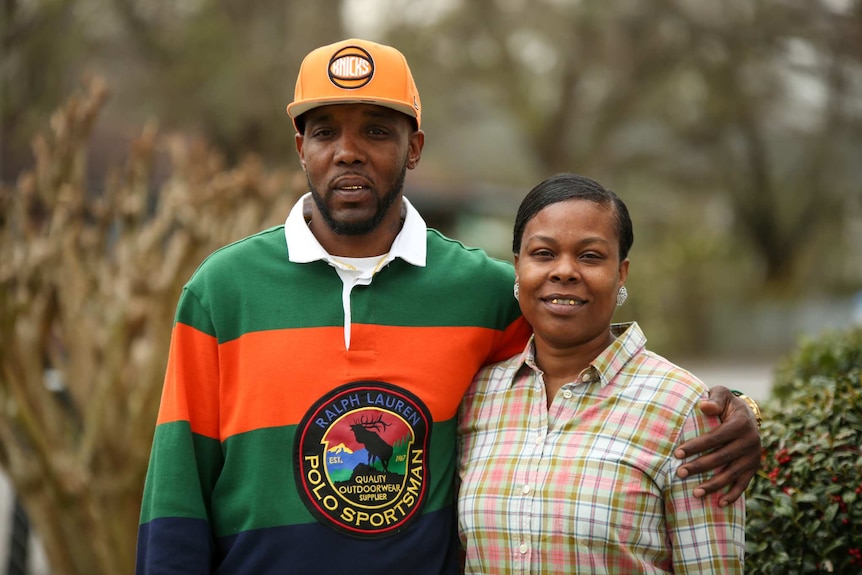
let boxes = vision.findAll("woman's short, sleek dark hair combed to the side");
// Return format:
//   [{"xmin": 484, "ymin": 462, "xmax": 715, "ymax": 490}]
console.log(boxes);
[{"xmin": 512, "ymin": 173, "xmax": 635, "ymax": 261}]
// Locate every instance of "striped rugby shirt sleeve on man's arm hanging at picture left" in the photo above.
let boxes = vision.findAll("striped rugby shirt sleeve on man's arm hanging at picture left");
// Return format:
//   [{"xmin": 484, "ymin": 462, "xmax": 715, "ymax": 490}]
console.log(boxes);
[{"xmin": 136, "ymin": 289, "xmax": 222, "ymax": 575}]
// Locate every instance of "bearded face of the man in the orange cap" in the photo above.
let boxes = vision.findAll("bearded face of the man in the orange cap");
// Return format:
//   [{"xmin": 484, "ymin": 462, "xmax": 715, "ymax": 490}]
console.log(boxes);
[{"xmin": 296, "ymin": 104, "xmax": 423, "ymax": 236}]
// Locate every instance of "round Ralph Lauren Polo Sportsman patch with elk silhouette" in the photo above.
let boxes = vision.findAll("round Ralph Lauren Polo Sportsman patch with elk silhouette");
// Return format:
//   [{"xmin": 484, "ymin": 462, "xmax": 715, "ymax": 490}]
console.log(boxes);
[{"xmin": 294, "ymin": 381, "xmax": 431, "ymax": 538}]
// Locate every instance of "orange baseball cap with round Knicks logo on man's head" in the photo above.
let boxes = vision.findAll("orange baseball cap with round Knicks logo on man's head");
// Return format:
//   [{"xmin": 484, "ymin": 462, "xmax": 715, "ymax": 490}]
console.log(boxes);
[{"xmin": 287, "ymin": 38, "xmax": 422, "ymax": 131}]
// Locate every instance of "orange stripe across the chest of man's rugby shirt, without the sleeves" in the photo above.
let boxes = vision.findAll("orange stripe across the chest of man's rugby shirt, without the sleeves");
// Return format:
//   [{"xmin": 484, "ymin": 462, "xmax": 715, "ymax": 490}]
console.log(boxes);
[{"xmin": 220, "ymin": 324, "xmax": 523, "ymax": 438}]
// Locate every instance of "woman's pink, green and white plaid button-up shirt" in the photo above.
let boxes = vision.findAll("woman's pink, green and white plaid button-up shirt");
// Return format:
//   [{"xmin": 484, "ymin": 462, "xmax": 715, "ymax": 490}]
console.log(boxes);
[{"xmin": 458, "ymin": 323, "xmax": 745, "ymax": 575}]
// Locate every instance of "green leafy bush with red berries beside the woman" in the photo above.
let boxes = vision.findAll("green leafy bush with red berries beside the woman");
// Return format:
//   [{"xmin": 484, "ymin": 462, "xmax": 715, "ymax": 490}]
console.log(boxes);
[{"xmin": 745, "ymin": 328, "xmax": 862, "ymax": 575}]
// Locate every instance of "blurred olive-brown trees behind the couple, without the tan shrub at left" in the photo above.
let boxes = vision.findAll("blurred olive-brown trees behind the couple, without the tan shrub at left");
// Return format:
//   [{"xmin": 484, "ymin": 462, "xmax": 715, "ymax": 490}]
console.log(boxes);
[{"xmin": 0, "ymin": 0, "xmax": 862, "ymax": 355}]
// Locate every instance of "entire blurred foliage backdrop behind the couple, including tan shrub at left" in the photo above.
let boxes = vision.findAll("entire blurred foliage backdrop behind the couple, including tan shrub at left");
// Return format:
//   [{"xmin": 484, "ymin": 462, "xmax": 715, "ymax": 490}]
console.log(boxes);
[{"xmin": 0, "ymin": 0, "xmax": 862, "ymax": 575}]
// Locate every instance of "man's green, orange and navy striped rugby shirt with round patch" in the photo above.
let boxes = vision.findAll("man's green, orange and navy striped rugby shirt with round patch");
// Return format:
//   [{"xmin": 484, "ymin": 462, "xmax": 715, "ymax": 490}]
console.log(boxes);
[{"xmin": 137, "ymin": 196, "xmax": 529, "ymax": 575}]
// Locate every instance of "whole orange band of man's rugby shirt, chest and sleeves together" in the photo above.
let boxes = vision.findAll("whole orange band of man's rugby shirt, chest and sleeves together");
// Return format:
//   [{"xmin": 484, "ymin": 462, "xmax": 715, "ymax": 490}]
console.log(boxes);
[{"xmin": 158, "ymin": 320, "xmax": 528, "ymax": 440}]
